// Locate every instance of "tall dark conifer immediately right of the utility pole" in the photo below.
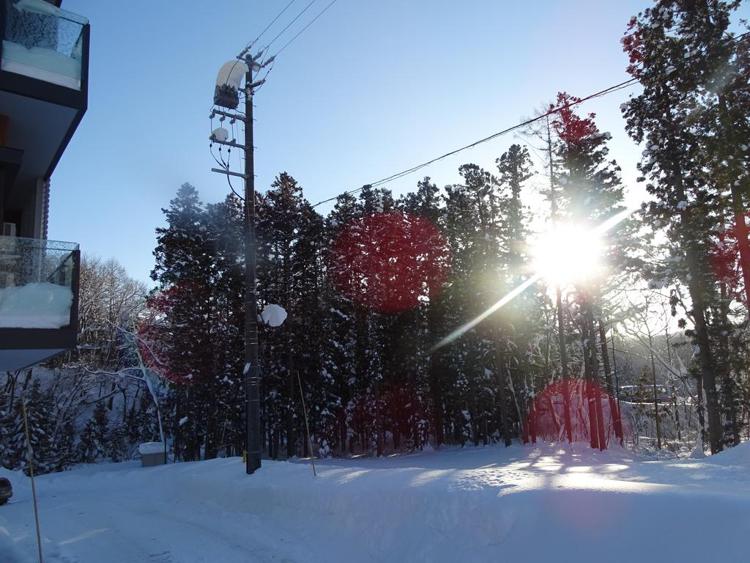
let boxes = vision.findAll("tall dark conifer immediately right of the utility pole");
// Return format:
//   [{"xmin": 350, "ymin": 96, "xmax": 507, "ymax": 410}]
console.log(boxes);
[{"xmin": 258, "ymin": 173, "xmax": 325, "ymax": 457}]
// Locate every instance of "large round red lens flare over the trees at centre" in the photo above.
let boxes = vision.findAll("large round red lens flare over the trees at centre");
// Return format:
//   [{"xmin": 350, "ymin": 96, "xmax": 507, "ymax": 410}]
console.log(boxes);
[{"xmin": 329, "ymin": 212, "xmax": 449, "ymax": 313}]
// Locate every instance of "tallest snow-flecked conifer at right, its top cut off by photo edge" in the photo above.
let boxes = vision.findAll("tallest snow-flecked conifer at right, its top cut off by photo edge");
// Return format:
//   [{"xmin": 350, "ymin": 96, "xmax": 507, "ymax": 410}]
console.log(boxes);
[{"xmin": 623, "ymin": 0, "xmax": 746, "ymax": 453}]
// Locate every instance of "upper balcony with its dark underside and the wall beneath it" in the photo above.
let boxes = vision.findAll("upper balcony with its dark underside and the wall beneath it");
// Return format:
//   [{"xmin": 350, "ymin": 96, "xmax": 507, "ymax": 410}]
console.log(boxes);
[{"xmin": 0, "ymin": 0, "xmax": 90, "ymax": 238}]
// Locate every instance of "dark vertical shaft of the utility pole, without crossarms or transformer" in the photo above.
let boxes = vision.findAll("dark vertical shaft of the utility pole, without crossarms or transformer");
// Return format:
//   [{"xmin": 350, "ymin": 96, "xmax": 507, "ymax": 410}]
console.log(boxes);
[{"xmin": 243, "ymin": 55, "xmax": 261, "ymax": 475}]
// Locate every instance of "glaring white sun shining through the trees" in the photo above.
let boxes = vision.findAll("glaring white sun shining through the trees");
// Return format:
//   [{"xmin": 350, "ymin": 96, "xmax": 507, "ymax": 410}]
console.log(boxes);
[{"xmin": 532, "ymin": 225, "xmax": 604, "ymax": 287}]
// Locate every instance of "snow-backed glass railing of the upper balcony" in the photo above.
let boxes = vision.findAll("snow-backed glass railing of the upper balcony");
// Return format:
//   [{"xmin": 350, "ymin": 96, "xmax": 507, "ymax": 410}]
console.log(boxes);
[{"xmin": 0, "ymin": 0, "xmax": 88, "ymax": 90}]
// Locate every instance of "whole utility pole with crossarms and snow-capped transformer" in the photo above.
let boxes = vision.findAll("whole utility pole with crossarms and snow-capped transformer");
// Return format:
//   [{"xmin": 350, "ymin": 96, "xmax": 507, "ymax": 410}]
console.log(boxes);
[{"xmin": 209, "ymin": 45, "xmax": 274, "ymax": 475}]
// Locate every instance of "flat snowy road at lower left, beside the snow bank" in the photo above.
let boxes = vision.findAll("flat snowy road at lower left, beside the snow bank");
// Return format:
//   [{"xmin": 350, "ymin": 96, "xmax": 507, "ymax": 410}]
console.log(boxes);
[{"xmin": 0, "ymin": 463, "xmax": 318, "ymax": 563}]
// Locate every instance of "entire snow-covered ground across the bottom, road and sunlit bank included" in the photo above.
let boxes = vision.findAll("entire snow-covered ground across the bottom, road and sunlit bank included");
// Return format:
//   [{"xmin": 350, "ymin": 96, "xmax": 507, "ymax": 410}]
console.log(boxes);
[{"xmin": 0, "ymin": 444, "xmax": 750, "ymax": 563}]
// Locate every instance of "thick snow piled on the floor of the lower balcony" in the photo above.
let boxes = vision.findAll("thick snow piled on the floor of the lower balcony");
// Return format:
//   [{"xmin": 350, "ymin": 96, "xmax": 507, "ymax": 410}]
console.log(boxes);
[{"xmin": 0, "ymin": 282, "xmax": 73, "ymax": 328}]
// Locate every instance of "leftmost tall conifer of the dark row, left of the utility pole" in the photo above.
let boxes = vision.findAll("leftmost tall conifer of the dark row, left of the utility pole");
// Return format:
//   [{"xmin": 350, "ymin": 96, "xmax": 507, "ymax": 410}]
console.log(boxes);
[{"xmin": 151, "ymin": 184, "xmax": 220, "ymax": 460}]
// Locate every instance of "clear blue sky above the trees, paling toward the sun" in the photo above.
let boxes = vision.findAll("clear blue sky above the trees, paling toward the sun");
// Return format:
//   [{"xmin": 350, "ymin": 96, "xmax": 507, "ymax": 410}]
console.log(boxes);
[{"xmin": 49, "ymin": 0, "xmax": 736, "ymax": 280}]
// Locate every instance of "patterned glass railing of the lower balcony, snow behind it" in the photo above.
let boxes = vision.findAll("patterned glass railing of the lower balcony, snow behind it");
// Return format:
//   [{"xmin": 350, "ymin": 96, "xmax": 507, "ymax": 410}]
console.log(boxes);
[{"xmin": 0, "ymin": 237, "xmax": 80, "ymax": 329}]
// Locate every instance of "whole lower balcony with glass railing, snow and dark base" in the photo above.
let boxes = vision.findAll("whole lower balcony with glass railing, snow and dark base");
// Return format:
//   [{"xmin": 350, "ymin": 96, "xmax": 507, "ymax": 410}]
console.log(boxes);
[{"xmin": 0, "ymin": 237, "xmax": 80, "ymax": 371}]
